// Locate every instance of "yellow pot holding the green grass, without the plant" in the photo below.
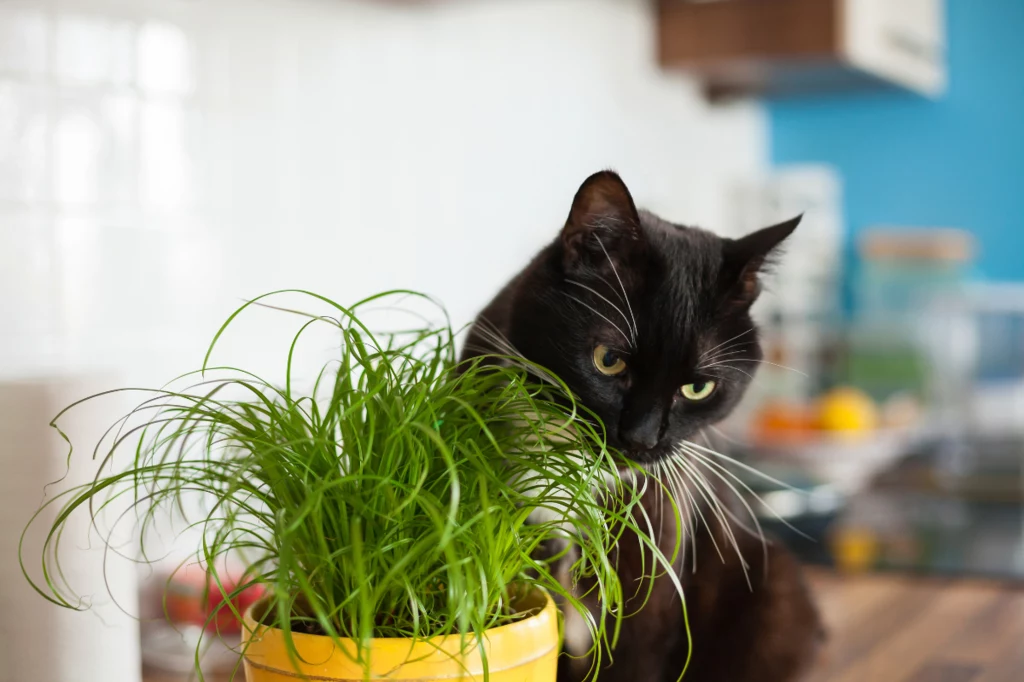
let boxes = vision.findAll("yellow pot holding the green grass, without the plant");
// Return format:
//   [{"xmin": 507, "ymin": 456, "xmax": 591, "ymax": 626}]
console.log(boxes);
[{"xmin": 243, "ymin": 592, "xmax": 559, "ymax": 682}]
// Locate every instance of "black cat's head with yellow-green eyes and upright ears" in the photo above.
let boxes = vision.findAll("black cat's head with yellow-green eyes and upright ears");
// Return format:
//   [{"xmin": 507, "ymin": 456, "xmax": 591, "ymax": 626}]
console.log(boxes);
[{"xmin": 507, "ymin": 171, "xmax": 800, "ymax": 462}]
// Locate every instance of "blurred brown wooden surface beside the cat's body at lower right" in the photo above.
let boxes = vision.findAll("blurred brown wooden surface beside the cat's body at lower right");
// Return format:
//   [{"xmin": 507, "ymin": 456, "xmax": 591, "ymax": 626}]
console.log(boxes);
[{"xmin": 145, "ymin": 572, "xmax": 1024, "ymax": 682}]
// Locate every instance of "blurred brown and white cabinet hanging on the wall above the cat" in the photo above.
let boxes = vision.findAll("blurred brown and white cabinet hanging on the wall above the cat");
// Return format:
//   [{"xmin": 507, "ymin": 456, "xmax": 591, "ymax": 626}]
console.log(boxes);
[{"xmin": 657, "ymin": 0, "xmax": 946, "ymax": 97}]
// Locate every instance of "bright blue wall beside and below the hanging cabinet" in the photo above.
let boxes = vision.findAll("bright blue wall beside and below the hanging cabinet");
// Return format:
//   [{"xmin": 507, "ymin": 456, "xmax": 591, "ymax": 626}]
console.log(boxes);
[{"xmin": 769, "ymin": 0, "xmax": 1024, "ymax": 280}]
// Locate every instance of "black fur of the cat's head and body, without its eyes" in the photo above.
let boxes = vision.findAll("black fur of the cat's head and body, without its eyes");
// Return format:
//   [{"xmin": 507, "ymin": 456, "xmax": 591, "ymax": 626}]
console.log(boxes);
[{"xmin": 465, "ymin": 171, "xmax": 822, "ymax": 682}]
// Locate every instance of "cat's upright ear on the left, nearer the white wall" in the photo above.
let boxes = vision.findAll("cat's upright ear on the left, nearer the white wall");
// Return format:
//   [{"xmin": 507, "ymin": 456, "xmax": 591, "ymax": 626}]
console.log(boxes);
[{"xmin": 561, "ymin": 171, "xmax": 643, "ymax": 270}]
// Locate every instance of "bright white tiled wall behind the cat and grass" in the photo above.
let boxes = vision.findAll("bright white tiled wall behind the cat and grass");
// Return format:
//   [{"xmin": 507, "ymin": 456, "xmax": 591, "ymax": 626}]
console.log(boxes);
[{"xmin": 0, "ymin": 0, "xmax": 766, "ymax": 382}]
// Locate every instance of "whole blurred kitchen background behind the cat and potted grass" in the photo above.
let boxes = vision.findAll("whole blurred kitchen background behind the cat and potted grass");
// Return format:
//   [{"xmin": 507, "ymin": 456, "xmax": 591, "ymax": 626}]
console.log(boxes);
[{"xmin": 0, "ymin": 0, "xmax": 1024, "ymax": 682}]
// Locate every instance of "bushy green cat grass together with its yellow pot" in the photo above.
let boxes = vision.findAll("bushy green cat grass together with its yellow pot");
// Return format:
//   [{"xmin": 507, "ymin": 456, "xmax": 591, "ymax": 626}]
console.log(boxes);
[{"xmin": 22, "ymin": 292, "xmax": 684, "ymax": 682}]
